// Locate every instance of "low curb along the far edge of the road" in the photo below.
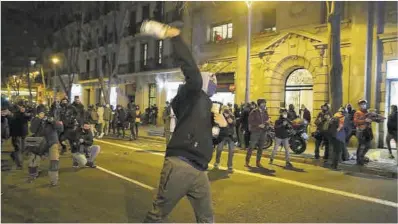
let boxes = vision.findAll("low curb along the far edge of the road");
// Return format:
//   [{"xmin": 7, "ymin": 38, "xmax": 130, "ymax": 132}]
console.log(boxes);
[{"xmin": 140, "ymin": 136, "xmax": 397, "ymax": 179}]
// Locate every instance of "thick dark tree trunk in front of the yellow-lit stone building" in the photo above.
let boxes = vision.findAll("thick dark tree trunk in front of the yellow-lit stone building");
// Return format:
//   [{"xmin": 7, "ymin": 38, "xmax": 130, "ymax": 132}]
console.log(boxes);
[{"xmin": 326, "ymin": 1, "xmax": 343, "ymax": 112}]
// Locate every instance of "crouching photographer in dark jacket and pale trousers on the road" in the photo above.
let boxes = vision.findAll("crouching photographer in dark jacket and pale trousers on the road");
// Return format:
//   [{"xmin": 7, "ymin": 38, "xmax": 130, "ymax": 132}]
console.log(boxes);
[{"xmin": 72, "ymin": 122, "xmax": 100, "ymax": 168}]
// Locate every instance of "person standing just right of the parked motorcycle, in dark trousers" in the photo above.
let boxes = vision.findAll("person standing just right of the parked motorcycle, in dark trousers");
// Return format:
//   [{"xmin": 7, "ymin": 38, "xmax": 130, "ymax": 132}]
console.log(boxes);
[{"xmin": 315, "ymin": 103, "xmax": 333, "ymax": 160}]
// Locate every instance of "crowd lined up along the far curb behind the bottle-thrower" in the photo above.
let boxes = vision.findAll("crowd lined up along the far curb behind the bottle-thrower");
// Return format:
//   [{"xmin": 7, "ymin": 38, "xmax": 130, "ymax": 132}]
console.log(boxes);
[{"xmin": 163, "ymin": 99, "xmax": 397, "ymax": 173}]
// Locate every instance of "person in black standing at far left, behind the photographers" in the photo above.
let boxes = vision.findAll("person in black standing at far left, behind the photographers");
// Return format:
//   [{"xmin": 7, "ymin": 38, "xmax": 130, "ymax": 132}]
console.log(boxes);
[{"xmin": 7, "ymin": 102, "xmax": 31, "ymax": 169}]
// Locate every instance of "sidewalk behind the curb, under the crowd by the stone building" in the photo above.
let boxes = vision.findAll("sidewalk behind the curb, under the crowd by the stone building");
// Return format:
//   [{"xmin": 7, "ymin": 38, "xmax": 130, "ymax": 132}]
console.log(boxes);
[{"xmin": 140, "ymin": 126, "xmax": 398, "ymax": 178}]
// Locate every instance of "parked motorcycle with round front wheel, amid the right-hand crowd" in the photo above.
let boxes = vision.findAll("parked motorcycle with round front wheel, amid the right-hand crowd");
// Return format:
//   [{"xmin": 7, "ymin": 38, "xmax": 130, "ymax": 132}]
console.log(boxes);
[{"xmin": 289, "ymin": 121, "xmax": 309, "ymax": 154}]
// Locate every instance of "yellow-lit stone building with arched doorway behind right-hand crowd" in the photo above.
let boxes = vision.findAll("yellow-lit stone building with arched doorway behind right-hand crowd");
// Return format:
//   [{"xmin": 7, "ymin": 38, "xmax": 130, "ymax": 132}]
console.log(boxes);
[{"xmin": 192, "ymin": 1, "xmax": 398, "ymax": 149}]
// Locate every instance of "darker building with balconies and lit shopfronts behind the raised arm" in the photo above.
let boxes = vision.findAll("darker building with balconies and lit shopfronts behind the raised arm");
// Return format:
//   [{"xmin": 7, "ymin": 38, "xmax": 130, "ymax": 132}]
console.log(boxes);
[{"xmin": 49, "ymin": 2, "xmax": 189, "ymax": 124}]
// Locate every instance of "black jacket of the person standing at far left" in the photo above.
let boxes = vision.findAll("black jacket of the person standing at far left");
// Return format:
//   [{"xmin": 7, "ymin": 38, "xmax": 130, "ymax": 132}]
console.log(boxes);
[{"xmin": 8, "ymin": 111, "xmax": 31, "ymax": 137}]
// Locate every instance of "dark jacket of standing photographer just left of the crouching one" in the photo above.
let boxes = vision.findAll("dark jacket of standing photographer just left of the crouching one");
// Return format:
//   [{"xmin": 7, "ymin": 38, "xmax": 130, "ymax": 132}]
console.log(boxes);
[{"xmin": 30, "ymin": 117, "xmax": 64, "ymax": 148}]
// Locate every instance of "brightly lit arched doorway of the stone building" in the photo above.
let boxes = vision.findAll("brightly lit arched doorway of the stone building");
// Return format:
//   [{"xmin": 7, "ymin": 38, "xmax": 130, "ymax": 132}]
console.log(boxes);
[{"xmin": 285, "ymin": 68, "xmax": 314, "ymax": 115}]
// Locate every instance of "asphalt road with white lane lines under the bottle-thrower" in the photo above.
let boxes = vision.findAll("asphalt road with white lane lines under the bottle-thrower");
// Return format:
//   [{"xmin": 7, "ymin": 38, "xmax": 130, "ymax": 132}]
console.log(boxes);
[{"xmin": 2, "ymin": 139, "xmax": 398, "ymax": 223}]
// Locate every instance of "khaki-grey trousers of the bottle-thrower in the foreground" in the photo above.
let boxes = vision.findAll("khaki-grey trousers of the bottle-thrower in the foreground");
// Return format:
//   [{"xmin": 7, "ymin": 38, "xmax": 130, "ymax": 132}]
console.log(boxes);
[{"xmin": 144, "ymin": 157, "xmax": 214, "ymax": 223}]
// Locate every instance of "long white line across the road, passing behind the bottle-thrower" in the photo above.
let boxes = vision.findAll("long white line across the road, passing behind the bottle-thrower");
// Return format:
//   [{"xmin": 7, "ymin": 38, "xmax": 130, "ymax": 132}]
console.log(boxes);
[{"xmin": 96, "ymin": 140, "xmax": 398, "ymax": 208}]
